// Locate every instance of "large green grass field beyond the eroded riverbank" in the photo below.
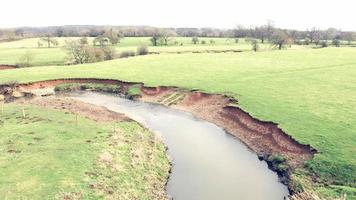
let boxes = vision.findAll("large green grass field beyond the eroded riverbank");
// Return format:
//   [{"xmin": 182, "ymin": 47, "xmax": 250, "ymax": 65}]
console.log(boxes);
[{"xmin": 0, "ymin": 48, "xmax": 356, "ymax": 199}]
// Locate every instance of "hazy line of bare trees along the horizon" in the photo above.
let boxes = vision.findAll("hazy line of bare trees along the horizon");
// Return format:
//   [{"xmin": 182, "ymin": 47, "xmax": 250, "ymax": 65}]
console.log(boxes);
[{"xmin": 0, "ymin": 22, "xmax": 356, "ymax": 45}]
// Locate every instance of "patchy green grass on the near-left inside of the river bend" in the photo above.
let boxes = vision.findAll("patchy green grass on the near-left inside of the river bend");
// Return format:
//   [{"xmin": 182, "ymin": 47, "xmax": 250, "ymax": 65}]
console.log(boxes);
[{"xmin": 0, "ymin": 104, "xmax": 169, "ymax": 199}]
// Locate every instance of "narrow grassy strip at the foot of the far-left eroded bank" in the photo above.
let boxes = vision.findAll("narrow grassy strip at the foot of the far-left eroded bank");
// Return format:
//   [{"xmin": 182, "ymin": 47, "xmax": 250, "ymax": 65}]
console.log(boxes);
[{"xmin": 54, "ymin": 83, "xmax": 121, "ymax": 93}]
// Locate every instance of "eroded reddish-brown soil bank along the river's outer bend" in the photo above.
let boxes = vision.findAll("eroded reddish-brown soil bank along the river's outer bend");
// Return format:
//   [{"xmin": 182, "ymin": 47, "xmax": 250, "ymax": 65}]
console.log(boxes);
[{"xmin": 0, "ymin": 79, "xmax": 316, "ymax": 190}]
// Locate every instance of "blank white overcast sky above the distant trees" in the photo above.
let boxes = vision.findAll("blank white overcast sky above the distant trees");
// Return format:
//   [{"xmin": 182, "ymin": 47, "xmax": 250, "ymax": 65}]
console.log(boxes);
[{"xmin": 0, "ymin": 0, "xmax": 356, "ymax": 31}]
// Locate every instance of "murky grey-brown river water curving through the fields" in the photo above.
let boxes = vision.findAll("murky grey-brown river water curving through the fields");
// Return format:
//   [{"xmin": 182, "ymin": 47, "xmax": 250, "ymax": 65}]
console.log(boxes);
[{"xmin": 68, "ymin": 92, "xmax": 288, "ymax": 200}]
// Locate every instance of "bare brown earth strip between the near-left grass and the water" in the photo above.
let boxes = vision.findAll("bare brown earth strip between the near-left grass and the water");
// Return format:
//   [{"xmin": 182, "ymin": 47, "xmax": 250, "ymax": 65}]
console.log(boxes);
[{"xmin": 24, "ymin": 96, "xmax": 129, "ymax": 122}]
